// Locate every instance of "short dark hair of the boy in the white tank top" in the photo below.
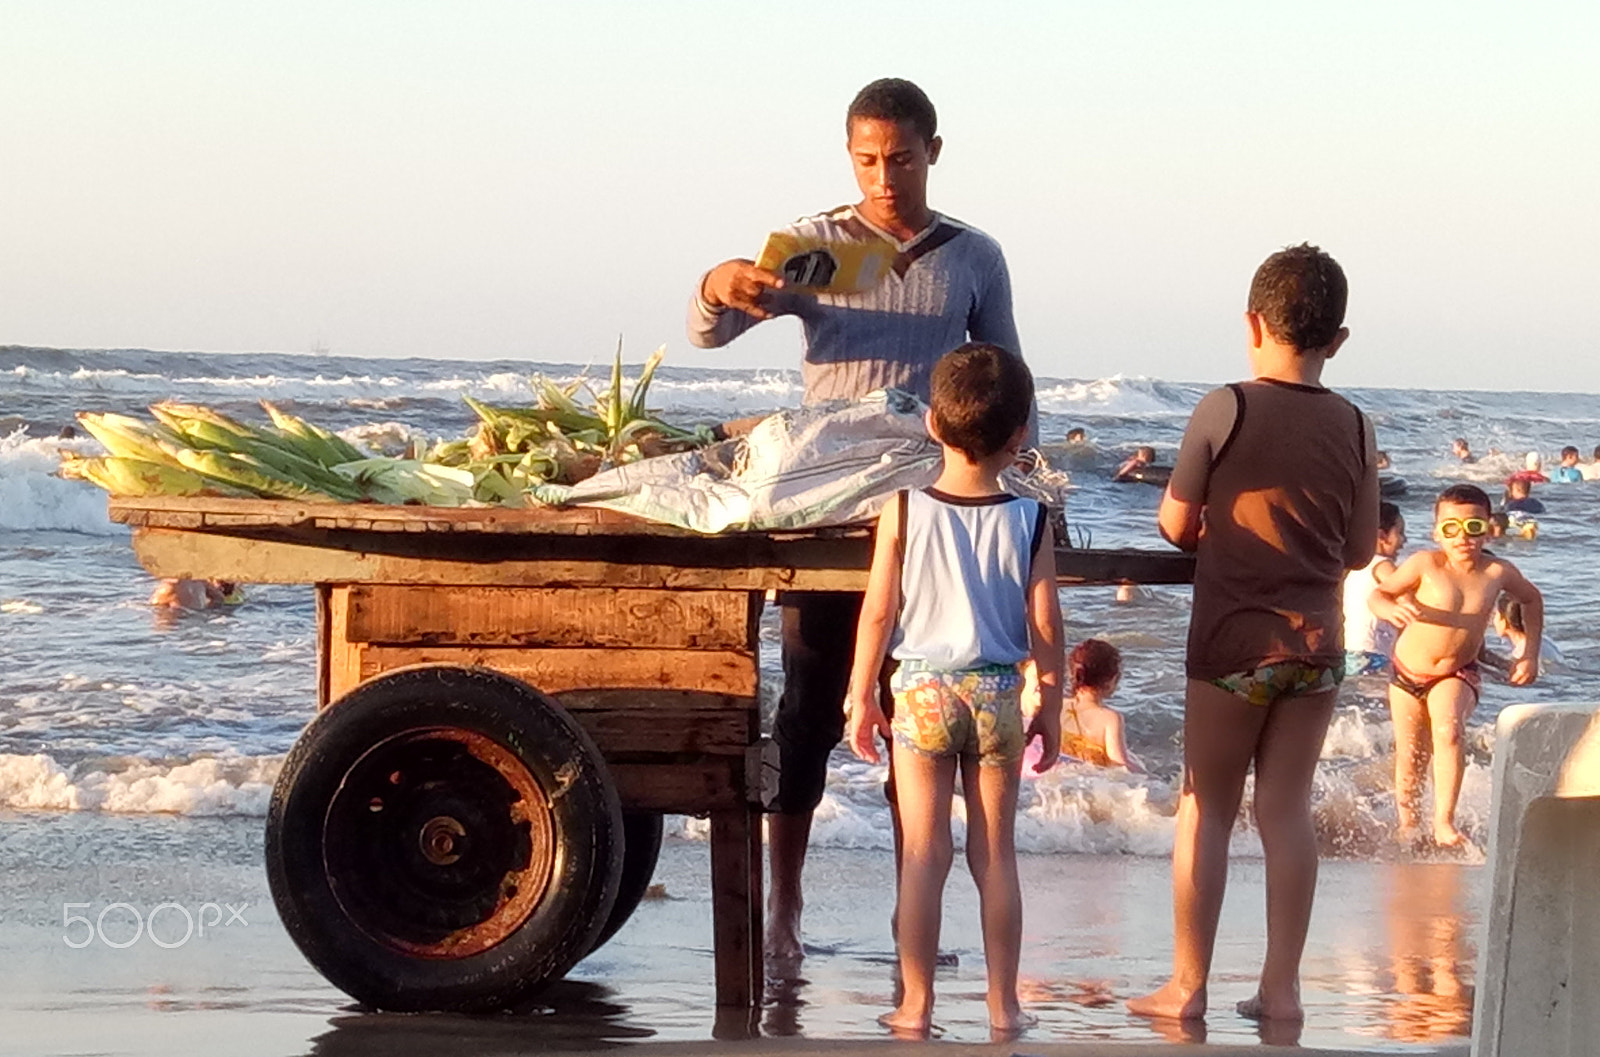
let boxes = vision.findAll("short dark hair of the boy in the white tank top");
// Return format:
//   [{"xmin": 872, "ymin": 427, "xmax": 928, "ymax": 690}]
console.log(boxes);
[{"xmin": 930, "ymin": 341, "xmax": 1034, "ymax": 462}]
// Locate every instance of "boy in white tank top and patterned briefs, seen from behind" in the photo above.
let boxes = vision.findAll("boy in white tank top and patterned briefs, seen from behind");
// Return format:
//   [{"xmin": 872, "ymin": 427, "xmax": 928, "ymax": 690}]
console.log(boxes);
[{"xmin": 846, "ymin": 342, "xmax": 1062, "ymax": 1038}]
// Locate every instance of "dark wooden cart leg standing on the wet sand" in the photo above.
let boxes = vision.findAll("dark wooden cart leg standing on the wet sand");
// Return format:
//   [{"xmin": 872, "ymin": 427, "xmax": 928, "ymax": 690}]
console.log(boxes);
[{"xmin": 710, "ymin": 806, "xmax": 765, "ymax": 1009}]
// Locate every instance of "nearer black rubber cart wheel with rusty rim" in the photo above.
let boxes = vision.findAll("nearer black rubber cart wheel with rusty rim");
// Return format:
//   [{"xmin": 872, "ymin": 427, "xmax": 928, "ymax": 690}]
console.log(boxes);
[{"xmin": 266, "ymin": 665, "xmax": 622, "ymax": 1012}]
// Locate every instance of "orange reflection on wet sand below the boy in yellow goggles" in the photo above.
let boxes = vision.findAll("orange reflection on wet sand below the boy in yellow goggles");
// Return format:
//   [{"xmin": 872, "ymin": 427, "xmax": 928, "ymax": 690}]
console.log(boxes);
[{"xmin": 1384, "ymin": 862, "xmax": 1475, "ymax": 1043}]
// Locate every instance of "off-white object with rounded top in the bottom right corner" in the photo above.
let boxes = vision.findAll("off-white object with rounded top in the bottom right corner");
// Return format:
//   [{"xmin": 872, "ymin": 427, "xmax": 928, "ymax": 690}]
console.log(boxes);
[{"xmin": 1472, "ymin": 704, "xmax": 1600, "ymax": 1057}]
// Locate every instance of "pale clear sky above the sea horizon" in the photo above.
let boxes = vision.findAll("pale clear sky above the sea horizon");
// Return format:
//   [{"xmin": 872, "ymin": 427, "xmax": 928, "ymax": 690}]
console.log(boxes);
[{"xmin": 0, "ymin": 0, "xmax": 1600, "ymax": 392}]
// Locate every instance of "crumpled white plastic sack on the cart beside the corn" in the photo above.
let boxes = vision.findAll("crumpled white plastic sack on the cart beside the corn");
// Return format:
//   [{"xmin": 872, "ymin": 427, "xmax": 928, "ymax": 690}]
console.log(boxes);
[{"xmin": 534, "ymin": 389, "xmax": 939, "ymax": 532}]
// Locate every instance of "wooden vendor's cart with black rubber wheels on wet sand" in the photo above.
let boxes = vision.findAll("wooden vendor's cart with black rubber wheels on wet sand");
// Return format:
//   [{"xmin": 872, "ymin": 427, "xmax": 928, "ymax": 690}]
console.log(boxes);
[{"xmin": 110, "ymin": 499, "xmax": 1192, "ymax": 1009}]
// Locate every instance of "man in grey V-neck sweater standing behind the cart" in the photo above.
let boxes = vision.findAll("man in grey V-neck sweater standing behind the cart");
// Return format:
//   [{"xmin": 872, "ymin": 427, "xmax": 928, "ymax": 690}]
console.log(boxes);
[{"xmin": 688, "ymin": 78, "xmax": 1021, "ymax": 963}]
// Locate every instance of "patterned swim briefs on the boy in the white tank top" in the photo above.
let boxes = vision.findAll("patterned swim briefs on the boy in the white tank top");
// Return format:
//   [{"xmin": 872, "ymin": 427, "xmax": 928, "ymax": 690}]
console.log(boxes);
[{"xmin": 890, "ymin": 660, "xmax": 1027, "ymax": 766}]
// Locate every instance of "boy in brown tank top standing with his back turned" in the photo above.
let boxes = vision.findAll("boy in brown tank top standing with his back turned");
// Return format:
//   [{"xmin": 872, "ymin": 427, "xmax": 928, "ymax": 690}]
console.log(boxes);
[{"xmin": 1128, "ymin": 245, "xmax": 1378, "ymax": 1020}]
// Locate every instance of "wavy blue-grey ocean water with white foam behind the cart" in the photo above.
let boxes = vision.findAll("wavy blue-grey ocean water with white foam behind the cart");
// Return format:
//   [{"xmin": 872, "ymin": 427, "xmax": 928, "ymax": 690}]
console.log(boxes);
[{"xmin": 0, "ymin": 340, "xmax": 1600, "ymax": 1049}]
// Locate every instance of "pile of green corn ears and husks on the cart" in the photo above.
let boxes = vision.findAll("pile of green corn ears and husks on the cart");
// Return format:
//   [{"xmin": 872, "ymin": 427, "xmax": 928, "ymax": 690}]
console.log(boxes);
[{"xmin": 61, "ymin": 349, "xmax": 710, "ymax": 507}]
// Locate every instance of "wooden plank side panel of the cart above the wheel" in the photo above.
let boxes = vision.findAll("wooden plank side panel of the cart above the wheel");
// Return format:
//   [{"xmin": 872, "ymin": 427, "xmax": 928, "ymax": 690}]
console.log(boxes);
[{"xmin": 318, "ymin": 584, "xmax": 762, "ymax": 814}]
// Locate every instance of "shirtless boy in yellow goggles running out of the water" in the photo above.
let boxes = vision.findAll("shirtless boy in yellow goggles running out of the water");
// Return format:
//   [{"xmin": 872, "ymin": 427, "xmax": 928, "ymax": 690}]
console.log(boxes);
[{"xmin": 1368, "ymin": 485, "xmax": 1544, "ymax": 848}]
